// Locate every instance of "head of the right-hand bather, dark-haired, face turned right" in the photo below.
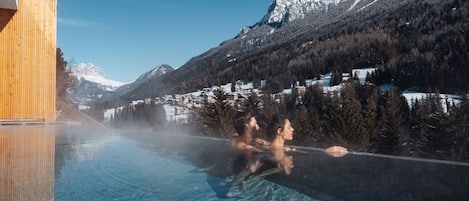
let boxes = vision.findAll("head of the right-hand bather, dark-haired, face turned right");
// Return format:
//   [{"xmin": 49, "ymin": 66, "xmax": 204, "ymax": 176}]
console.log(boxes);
[{"xmin": 268, "ymin": 114, "xmax": 295, "ymax": 140}]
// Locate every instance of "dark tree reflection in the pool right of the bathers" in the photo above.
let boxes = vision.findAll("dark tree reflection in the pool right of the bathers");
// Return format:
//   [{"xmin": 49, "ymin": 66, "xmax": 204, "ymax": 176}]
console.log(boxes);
[{"xmin": 274, "ymin": 149, "xmax": 469, "ymax": 201}]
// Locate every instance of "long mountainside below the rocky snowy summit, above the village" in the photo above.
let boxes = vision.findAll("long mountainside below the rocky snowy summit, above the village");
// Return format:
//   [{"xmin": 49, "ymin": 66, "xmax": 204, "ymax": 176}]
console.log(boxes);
[{"xmin": 98, "ymin": 0, "xmax": 469, "ymax": 101}]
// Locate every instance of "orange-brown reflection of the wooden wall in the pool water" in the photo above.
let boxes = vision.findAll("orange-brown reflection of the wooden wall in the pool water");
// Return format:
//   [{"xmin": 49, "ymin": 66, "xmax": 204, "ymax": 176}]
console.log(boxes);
[{"xmin": 0, "ymin": 126, "xmax": 55, "ymax": 201}]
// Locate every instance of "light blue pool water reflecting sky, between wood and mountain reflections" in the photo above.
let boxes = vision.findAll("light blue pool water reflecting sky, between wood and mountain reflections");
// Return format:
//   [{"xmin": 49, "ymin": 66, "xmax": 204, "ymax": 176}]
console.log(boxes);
[{"xmin": 54, "ymin": 126, "xmax": 314, "ymax": 201}]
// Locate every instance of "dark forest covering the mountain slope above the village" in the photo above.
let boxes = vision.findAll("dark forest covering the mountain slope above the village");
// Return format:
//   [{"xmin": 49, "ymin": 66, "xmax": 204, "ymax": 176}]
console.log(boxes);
[{"xmin": 159, "ymin": 0, "xmax": 469, "ymax": 97}]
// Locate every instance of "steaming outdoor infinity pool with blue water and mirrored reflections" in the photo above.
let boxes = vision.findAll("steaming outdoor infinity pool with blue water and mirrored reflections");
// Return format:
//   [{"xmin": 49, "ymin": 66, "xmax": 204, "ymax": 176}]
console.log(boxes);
[{"xmin": 0, "ymin": 125, "xmax": 469, "ymax": 201}]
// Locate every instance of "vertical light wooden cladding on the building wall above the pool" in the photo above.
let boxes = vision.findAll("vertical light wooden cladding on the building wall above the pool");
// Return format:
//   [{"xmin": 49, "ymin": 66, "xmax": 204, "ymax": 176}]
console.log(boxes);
[{"xmin": 0, "ymin": 0, "xmax": 57, "ymax": 121}]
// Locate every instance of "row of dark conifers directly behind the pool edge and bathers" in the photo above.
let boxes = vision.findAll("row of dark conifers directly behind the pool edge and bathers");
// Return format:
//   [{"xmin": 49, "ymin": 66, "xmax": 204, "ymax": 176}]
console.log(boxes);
[{"xmin": 199, "ymin": 80, "xmax": 469, "ymax": 161}]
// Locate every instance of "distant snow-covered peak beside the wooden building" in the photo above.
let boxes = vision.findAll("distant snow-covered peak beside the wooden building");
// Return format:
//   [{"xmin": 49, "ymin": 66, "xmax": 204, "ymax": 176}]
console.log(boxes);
[{"xmin": 70, "ymin": 63, "xmax": 125, "ymax": 104}]
